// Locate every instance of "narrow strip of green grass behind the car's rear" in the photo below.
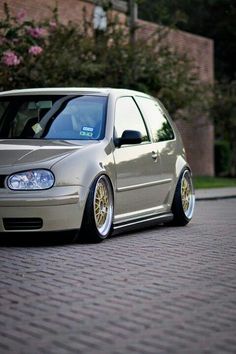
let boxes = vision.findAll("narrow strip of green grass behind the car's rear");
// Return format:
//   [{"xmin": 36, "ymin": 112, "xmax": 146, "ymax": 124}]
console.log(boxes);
[{"xmin": 193, "ymin": 176, "xmax": 236, "ymax": 189}]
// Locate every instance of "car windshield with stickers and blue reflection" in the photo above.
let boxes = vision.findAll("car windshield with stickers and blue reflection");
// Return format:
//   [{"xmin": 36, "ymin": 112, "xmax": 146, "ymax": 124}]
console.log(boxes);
[{"xmin": 0, "ymin": 95, "xmax": 107, "ymax": 140}]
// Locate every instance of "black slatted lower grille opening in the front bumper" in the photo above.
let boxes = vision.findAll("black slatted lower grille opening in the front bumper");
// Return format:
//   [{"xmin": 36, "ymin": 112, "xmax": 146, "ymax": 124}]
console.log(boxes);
[{"xmin": 3, "ymin": 218, "xmax": 43, "ymax": 231}]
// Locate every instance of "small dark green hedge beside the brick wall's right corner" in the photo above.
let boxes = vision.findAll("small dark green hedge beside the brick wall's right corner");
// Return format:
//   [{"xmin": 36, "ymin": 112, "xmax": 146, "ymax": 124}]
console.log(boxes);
[{"xmin": 215, "ymin": 140, "xmax": 232, "ymax": 176}]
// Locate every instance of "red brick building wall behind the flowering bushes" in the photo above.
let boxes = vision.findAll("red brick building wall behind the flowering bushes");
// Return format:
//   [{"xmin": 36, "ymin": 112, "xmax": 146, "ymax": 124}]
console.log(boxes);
[{"xmin": 0, "ymin": 0, "xmax": 214, "ymax": 176}]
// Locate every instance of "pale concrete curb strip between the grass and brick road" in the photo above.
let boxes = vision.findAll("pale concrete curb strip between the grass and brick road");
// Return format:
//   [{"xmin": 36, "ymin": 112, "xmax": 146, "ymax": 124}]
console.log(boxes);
[{"xmin": 195, "ymin": 187, "xmax": 236, "ymax": 200}]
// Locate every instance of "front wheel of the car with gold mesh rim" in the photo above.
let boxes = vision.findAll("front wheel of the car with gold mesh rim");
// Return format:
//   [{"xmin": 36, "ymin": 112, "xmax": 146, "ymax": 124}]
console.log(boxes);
[{"xmin": 77, "ymin": 175, "xmax": 114, "ymax": 242}]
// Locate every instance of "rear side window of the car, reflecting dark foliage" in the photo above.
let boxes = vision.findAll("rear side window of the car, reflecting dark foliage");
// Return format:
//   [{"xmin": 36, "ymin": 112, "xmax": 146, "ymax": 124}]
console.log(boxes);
[{"xmin": 136, "ymin": 97, "xmax": 175, "ymax": 142}]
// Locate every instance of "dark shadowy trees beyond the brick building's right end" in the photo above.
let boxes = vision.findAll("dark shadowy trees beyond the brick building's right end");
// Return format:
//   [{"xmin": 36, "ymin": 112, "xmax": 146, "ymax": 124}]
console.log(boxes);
[{"xmin": 136, "ymin": 0, "xmax": 236, "ymax": 175}]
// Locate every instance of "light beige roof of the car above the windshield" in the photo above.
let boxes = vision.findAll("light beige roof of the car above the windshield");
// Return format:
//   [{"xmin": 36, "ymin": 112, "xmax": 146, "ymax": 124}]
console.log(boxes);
[{"xmin": 0, "ymin": 87, "xmax": 150, "ymax": 97}]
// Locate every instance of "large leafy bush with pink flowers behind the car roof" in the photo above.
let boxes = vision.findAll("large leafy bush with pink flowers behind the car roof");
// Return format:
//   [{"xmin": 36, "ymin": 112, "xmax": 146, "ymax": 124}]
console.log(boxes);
[{"xmin": 0, "ymin": 1, "xmax": 206, "ymax": 118}]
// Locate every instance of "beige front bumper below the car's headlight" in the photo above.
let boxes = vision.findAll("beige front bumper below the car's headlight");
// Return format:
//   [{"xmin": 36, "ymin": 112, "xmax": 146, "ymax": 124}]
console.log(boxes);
[{"xmin": 0, "ymin": 186, "xmax": 88, "ymax": 232}]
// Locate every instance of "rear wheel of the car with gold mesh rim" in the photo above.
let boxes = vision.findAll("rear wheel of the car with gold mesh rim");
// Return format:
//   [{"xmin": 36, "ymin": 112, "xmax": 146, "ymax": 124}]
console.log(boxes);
[{"xmin": 171, "ymin": 169, "xmax": 195, "ymax": 226}]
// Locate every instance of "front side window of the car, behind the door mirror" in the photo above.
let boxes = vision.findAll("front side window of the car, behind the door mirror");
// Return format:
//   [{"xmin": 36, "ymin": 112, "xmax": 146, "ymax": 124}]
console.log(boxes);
[{"xmin": 115, "ymin": 97, "xmax": 150, "ymax": 142}]
